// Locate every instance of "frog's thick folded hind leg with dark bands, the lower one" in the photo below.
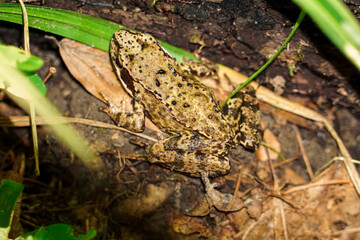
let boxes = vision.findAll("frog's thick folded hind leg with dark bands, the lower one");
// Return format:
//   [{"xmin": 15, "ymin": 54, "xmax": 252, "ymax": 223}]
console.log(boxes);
[{"xmin": 147, "ymin": 133, "xmax": 230, "ymax": 177}]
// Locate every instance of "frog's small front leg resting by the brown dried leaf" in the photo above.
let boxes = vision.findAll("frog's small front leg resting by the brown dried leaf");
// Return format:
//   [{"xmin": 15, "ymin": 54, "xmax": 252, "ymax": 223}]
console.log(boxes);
[{"xmin": 99, "ymin": 100, "xmax": 145, "ymax": 132}]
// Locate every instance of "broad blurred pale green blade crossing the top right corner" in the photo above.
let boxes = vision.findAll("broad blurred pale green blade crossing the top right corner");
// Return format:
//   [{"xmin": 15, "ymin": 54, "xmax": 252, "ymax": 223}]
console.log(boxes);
[{"xmin": 293, "ymin": 0, "xmax": 360, "ymax": 70}]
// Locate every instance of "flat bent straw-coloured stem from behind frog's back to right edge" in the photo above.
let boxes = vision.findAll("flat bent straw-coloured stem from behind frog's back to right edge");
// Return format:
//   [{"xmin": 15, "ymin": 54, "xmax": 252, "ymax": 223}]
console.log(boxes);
[{"xmin": 219, "ymin": 65, "xmax": 360, "ymax": 195}]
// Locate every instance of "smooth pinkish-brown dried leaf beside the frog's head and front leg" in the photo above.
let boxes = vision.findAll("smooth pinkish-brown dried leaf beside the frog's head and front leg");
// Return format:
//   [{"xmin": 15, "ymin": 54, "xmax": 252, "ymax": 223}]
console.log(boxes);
[{"xmin": 59, "ymin": 38, "xmax": 160, "ymax": 132}]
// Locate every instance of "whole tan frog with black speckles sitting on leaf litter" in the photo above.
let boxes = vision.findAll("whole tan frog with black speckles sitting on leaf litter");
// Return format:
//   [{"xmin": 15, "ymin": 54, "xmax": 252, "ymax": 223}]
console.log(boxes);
[{"xmin": 100, "ymin": 29, "xmax": 262, "ymax": 177}]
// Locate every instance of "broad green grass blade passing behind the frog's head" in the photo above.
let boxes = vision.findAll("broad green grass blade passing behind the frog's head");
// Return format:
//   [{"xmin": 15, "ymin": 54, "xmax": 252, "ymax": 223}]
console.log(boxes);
[{"xmin": 0, "ymin": 3, "xmax": 197, "ymax": 62}]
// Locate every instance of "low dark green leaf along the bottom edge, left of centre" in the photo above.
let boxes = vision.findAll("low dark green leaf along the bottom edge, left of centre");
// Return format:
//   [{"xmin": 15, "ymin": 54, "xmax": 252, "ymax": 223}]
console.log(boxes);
[{"xmin": 15, "ymin": 223, "xmax": 96, "ymax": 240}]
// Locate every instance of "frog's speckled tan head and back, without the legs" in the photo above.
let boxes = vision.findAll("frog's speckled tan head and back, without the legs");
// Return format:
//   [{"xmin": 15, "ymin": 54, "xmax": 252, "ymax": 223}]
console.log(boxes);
[{"xmin": 113, "ymin": 30, "xmax": 228, "ymax": 138}]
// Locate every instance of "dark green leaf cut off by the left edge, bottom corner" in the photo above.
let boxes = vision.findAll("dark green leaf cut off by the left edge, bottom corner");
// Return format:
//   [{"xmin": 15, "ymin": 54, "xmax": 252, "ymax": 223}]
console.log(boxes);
[{"xmin": 0, "ymin": 179, "xmax": 24, "ymax": 239}]
